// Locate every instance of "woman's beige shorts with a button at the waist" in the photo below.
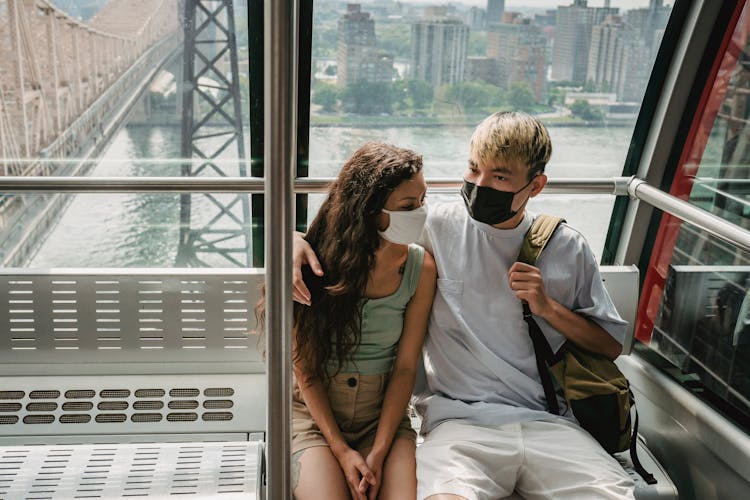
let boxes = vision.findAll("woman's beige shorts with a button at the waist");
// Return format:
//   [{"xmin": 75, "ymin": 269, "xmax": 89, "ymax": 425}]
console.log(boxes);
[{"xmin": 292, "ymin": 373, "xmax": 417, "ymax": 453}]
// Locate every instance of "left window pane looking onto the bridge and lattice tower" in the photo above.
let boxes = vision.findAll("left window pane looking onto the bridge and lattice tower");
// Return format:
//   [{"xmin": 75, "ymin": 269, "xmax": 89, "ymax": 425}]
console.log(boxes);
[{"xmin": 0, "ymin": 0, "xmax": 250, "ymax": 267}]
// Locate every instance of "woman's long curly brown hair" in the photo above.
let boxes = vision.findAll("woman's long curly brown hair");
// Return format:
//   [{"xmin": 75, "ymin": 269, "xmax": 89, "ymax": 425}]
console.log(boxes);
[{"xmin": 256, "ymin": 142, "xmax": 422, "ymax": 380}]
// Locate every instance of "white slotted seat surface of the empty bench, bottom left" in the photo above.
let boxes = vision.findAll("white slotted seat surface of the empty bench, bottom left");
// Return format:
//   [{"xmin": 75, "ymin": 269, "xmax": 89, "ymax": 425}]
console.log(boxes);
[{"xmin": 0, "ymin": 442, "xmax": 262, "ymax": 500}]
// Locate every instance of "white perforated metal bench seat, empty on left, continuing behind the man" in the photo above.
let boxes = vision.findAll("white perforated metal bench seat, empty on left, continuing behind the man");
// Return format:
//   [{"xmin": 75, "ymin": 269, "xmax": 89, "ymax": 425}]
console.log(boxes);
[{"xmin": 0, "ymin": 266, "xmax": 677, "ymax": 500}]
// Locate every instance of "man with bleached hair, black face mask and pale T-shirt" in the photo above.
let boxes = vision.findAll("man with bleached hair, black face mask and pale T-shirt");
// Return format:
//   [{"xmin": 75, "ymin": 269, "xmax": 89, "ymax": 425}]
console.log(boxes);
[{"xmin": 294, "ymin": 112, "xmax": 633, "ymax": 500}]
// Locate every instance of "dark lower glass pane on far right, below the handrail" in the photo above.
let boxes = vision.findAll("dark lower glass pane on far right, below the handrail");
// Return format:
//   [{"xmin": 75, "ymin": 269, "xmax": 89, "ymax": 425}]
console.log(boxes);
[{"xmin": 649, "ymin": 229, "xmax": 750, "ymax": 414}]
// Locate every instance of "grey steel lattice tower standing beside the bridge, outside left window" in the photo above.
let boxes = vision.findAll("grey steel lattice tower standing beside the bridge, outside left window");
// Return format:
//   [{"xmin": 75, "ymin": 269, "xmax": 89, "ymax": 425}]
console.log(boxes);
[{"xmin": 177, "ymin": 0, "xmax": 252, "ymax": 267}]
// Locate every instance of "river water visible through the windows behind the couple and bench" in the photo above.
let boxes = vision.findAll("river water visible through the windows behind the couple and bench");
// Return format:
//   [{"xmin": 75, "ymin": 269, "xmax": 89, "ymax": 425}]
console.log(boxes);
[{"xmin": 30, "ymin": 126, "xmax": 632, "ymax": 268}]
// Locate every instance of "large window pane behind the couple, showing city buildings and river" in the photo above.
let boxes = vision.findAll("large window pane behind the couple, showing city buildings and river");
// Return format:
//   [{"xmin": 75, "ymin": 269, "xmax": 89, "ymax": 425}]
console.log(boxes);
[{"xmin": 310, "ymin": 0, "xmax": 671, "ymax": 255}]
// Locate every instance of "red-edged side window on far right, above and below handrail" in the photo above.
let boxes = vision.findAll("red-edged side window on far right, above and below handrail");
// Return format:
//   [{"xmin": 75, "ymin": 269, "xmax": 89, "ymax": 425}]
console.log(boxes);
[{"xmin": 636, "ymin": 1, "xmax": 750, "ymax": 426}]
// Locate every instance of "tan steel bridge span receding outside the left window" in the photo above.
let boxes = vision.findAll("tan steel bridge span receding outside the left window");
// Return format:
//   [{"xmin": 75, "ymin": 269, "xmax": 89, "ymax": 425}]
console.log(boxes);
[{"xmin": 0, "ymin": 0, "xmax": 180, "ymax": 266}]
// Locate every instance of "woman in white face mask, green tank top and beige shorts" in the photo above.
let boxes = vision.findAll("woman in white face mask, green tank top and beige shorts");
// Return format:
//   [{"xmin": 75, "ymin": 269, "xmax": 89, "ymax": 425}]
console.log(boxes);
[{"xmin": 268, "ymin": 143, "xmax": 436, "ymax": 500}]
